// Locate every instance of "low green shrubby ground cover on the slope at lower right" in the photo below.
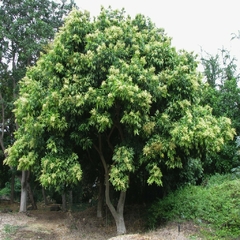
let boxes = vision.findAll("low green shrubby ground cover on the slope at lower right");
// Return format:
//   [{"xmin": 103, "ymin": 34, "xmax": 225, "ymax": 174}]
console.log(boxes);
[{"xmin": 148, "ymin": 174, "xmax": 240, "ymax": 239}]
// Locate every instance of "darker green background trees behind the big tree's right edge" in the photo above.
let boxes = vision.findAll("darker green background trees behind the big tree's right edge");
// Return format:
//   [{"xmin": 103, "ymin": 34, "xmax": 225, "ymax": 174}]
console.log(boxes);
[{"xmin": 202, "ymin": 49, "xmax": 240, "ymax": 173}]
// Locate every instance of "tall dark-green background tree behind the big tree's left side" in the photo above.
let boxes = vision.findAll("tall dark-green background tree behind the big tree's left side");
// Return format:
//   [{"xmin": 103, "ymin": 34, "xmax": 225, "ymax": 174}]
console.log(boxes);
[{"xmin": 0, "ymin": 0, "xmax": 75, "ymax": 211}]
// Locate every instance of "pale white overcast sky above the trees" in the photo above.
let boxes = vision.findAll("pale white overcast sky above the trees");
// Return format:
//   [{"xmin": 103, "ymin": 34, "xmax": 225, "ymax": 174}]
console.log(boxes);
[{"xmin": 75, "ymin": 0, "xmax": 240, "ymax": 61}]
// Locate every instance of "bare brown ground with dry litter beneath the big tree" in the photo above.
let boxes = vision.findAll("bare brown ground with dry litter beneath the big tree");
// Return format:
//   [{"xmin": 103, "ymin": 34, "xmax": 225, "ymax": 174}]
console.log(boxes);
[{"xmin": 0, "ymin": 204, "xmax": 200, "ymax": 240}]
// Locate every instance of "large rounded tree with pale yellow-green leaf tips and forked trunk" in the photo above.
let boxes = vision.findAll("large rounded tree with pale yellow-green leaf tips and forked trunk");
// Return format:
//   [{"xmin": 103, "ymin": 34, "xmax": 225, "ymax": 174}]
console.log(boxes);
[{"xmin": 6, "ymin": 8, "xmax": 234, "ymax": 234}]
